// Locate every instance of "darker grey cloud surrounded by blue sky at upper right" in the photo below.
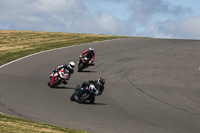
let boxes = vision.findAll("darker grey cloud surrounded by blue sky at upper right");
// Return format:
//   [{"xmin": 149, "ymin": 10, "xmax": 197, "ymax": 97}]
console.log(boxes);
[{"xmin": 128, "ymin": 0, "xmax": 191, "ymax": 26}]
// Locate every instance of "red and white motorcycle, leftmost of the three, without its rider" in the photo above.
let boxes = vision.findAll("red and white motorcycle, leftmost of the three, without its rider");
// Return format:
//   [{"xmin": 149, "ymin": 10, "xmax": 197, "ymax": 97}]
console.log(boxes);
[{"xmin": 48, "ymin": 68, "xmax": 69, "ymax": 88}]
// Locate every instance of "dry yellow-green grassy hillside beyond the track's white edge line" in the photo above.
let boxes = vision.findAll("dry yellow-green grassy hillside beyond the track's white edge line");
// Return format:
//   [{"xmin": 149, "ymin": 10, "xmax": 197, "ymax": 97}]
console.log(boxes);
[{"xmin": 0, "ymin": 30, "xmax": 128, "ymax": 65}]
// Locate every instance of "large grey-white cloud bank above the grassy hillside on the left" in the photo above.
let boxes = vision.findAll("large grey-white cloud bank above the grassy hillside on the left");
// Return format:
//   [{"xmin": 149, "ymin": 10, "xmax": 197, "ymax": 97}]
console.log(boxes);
[{"xmin": 0, "ymin": 0, "xmax": 133, "ymax": 35}]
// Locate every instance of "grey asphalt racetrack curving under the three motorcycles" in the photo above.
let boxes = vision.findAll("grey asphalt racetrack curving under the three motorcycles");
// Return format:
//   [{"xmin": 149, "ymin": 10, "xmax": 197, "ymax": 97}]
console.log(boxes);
[{"xmin": 0, "ymin": 38, "xmax": 200, "ymax": 133}]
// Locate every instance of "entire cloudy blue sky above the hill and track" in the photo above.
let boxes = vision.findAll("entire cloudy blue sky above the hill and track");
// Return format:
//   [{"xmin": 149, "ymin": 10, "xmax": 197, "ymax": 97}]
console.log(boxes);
[{"xmin": 0, "ymin": 0, "xmax": 200, "ymax": 40}]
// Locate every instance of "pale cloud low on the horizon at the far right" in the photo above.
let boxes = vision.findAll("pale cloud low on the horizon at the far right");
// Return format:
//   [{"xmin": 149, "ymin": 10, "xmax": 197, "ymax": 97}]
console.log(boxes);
[{"xmin": 138, "ymin": 16, "xmax": 200, "ymax": 39}]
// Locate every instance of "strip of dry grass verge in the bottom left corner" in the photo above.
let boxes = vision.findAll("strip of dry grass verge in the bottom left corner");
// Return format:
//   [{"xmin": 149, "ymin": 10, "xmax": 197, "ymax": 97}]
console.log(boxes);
[{"xmin": 0, "ymin": 114, "xmax": 89, "ymax": 133}]
